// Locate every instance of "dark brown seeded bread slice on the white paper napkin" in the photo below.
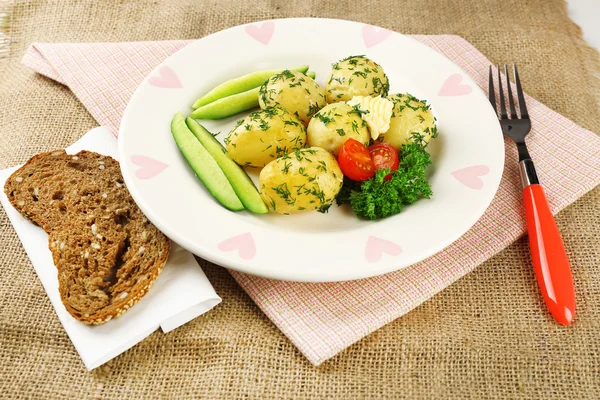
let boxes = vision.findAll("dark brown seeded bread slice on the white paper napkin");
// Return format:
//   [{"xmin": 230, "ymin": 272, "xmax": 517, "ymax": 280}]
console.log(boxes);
[{"xmin": 4, "ymin": 151, "xmax": 170, "ymax": 325}]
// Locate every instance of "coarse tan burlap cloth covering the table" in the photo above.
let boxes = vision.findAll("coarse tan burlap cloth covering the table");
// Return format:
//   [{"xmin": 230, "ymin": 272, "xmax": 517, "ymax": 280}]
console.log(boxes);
[{"xmin": 0, "ymin": 0, "xmax": 600, "ymax": 399}]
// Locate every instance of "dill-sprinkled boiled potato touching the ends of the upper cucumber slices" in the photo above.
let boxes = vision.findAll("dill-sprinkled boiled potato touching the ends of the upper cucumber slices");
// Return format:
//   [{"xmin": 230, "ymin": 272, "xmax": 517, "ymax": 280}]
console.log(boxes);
[{"xmin": 258, "ymin": 70, "xmax": 327, "ymax": 126}]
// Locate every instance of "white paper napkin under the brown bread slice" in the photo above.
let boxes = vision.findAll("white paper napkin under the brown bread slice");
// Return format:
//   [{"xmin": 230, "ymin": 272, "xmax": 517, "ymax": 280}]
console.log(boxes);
[{"xmin": 0, "ymin": 127, "xmax": 221, "ymax": 370}]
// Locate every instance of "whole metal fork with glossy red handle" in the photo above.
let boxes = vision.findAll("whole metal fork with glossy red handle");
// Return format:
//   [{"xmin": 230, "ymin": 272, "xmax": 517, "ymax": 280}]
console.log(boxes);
[{"xmin": 489, "ymin": 64, "xmax": 575, "ymax": 325}]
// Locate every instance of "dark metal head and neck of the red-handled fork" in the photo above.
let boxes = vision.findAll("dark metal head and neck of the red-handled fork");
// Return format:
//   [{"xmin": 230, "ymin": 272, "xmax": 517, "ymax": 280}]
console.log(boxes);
[{"xmin": 489, "ymin": 64, "xmax": 539, "ymax": 187}]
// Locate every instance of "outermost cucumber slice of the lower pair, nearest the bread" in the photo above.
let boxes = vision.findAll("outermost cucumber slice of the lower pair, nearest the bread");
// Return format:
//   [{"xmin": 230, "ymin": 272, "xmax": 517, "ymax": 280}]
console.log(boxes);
[{"xmin": 171, "ymin": 113, "xmax": 244, "ymax": 211}]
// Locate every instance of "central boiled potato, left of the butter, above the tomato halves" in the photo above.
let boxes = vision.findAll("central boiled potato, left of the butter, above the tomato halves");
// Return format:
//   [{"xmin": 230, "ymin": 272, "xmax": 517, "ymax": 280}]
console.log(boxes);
[{"xmin": 307, "ymin": 103, "xmax": 371, "ymax": 156}]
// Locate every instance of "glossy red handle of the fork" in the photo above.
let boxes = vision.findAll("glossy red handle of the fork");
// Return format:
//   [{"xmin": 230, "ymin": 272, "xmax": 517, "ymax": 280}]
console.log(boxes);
[{"xmin": 523, "ymin": 184, "xmax": 575, "ymax": 325}]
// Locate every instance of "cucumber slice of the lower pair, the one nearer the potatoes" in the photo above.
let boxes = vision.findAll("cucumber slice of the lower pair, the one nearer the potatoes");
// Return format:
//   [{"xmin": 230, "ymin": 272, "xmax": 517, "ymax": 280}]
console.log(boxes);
[{"xmin": 185, "ymin": 117, "xmax": 269, "ymax": 214}]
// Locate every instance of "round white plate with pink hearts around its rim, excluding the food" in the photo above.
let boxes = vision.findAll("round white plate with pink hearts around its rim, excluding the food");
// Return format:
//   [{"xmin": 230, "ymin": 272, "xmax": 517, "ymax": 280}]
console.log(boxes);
[{"xmin": 119, "ymin": 18, "xmax": 504, "ymax": 282}]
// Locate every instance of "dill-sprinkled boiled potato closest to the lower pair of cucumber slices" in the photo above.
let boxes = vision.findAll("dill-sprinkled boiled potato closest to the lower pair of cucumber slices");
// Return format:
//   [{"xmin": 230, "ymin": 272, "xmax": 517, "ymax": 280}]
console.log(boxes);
[{"xmin": 225, "ymin": 107, "xmax": 306, "ymax": 167}]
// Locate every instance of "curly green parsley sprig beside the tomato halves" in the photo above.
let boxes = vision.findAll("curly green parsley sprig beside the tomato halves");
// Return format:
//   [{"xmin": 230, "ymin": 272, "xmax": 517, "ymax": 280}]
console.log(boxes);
[{"xmin": 337, "ymin": 142, "xmax": 432, "ymax": 220}]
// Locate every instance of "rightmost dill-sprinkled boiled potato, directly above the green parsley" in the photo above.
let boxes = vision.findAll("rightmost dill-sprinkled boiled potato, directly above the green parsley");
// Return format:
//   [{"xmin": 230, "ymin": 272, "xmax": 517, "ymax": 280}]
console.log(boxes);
[{"xmin": 379, "ymin": 94, "xmax": 437, "ymax": 150}]
